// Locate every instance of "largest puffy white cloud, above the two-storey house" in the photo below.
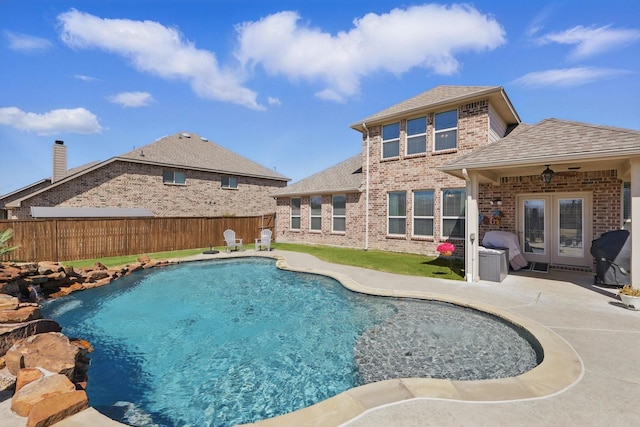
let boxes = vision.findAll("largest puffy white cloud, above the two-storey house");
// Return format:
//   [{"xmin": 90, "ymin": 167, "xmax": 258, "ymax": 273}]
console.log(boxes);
[{"xmin": 236, "ymin": 4, "xmax": 506, "ymax": 101}]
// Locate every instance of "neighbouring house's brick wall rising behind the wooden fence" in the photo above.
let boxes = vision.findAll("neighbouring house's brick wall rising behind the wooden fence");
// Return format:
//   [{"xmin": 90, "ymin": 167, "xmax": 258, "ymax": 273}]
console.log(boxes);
[{"xmin": 13, "ymin": 161, "xmax": 286, "ymax": 218}]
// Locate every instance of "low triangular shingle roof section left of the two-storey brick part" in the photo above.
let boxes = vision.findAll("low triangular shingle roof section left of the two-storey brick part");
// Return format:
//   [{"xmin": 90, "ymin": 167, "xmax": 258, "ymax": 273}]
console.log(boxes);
[{"xmin": 272, "ymin": 154, "xmax": 362, "ymax": 197}]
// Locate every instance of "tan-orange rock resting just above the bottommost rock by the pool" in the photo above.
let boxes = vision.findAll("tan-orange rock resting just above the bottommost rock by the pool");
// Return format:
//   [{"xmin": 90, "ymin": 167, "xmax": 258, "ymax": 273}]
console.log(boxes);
[{"xmin": 11, "ymin": 374, "xmax": 76, "ymax": 417}]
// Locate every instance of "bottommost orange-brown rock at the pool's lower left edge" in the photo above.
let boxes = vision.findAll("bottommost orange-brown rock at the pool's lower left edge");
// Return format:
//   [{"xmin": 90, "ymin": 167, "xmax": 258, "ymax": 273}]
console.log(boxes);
[{"xmin": 27, "ymin": 390, "xmax": 89, "ymax": 427}]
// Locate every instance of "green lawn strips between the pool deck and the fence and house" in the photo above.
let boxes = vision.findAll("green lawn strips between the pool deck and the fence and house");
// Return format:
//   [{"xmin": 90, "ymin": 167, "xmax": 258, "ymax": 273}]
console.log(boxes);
[{"xmin": 62, "ymin": 243, "xmax": 464, "ymax": 280}]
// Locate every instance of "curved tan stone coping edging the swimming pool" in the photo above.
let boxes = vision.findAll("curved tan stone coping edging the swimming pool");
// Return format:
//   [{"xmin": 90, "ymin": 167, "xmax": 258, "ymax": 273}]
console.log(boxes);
[{"xmin": 37, "ymin": 251, "xmax": 584, "ymax": 427}]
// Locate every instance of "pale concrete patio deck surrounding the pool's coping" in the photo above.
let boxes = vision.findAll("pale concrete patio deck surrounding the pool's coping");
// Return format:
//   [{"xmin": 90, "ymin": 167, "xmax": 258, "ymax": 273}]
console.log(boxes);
[{"xmin": 0, "ymin": 250, "xmax": 640, "ymax": 427}]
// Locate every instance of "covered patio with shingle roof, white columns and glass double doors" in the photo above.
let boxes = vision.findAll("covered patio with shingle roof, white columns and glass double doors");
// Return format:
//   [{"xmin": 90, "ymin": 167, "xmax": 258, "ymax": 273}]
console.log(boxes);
[{"xmin": 438, "ymin": 119, "xmax": 640, "ymax": 287}]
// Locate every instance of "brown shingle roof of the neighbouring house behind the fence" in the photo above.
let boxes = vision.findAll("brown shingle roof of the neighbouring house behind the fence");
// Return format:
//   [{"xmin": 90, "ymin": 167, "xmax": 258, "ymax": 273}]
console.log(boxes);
[{"xmin": 0, "ymin": 132, "xmax": 289, "ymax": 207}]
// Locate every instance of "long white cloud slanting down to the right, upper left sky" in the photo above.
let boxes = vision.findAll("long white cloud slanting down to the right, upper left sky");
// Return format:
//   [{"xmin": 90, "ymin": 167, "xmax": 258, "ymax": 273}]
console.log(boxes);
[{"xmin": 58, "ymin": 9, "xmax": 264, "ymax": 110}]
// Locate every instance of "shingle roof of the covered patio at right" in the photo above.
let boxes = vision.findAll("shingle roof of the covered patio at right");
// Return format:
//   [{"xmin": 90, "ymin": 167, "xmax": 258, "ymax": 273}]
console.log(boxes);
[{"xmin": 438, "ymin": 118, "xmax": 640, "ymax": 171}]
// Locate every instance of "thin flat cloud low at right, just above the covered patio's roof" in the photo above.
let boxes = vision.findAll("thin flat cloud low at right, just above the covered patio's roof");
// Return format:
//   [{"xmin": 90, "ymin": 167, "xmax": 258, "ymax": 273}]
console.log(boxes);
[{"xmin": 513, "ymin": 67, "xmax": 629, "ymax": 87}]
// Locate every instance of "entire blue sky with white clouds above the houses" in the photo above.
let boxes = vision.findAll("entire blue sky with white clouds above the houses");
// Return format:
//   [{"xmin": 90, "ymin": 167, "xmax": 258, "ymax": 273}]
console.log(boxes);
[{"xmin": 0, "ymin": 0, "xmax": 640, "ymax": 194}]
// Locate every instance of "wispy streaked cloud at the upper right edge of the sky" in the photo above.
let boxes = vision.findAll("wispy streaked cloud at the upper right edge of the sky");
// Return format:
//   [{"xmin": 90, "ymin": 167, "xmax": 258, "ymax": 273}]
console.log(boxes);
[{"xmin": 538, "ymin": 25, "xmax": 640, "ymax": 59}]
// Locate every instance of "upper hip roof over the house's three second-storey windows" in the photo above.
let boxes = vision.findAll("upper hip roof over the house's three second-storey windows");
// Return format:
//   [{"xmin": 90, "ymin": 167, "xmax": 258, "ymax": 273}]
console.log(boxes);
[{"xmin": 351, "ymin": 85, "xmax": 520, "ymax": 132}]
